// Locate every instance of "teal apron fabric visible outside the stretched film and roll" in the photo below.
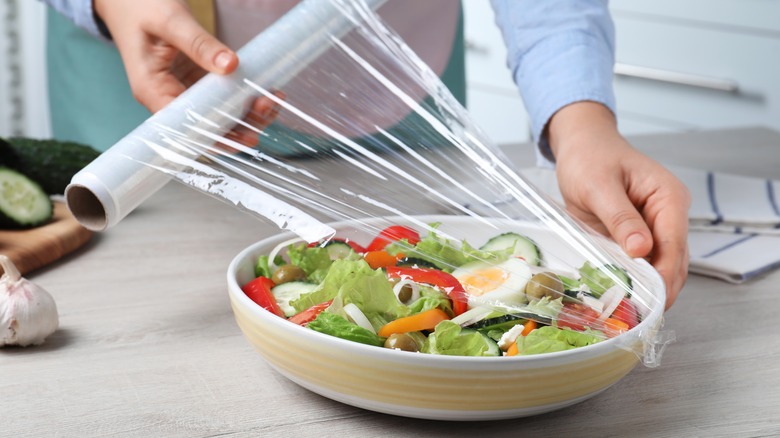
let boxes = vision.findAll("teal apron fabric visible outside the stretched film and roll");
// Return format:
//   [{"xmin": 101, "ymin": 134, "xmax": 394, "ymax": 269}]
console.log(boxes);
[{"xmin": 46, "ymin": 8, "xmax": 466, "ymax": 151}]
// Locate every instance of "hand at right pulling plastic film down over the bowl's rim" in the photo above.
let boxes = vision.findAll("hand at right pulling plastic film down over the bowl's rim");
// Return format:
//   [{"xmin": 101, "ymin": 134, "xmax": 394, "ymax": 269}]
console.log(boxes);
[{"xmin": 548, "ymin": 102, "xmax": 691, "ymax": 309}]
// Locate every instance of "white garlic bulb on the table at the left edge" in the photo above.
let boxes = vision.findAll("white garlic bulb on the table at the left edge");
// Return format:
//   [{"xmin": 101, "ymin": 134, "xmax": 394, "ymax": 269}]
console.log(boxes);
[{"xmin": 0, "ymin": 255, "xmax": 59, "ymax": 347}]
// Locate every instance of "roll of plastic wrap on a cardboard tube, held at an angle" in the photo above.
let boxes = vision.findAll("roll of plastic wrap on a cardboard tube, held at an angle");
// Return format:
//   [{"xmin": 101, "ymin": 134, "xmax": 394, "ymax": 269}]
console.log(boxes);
[{"xmin": 65, "ymin": 0, "xmax": 386, "ymax": 231}]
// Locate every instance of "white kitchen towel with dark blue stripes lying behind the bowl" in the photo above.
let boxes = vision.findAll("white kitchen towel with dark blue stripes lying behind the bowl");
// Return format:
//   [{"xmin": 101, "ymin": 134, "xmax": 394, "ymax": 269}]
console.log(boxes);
[{"xmin": 442, "ymin": 166, "xmax": 780, "ymax": 283}]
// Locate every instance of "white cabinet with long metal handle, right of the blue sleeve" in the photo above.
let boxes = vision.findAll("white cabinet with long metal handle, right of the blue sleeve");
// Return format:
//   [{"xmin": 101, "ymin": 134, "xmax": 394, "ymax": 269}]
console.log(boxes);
[{"xmin": 611, "ymin": 0, "xmax": 780, "ymax": 134}]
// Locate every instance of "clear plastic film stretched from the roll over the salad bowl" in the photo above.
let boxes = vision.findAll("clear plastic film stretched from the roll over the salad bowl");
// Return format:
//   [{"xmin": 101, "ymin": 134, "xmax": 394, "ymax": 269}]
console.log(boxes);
[{"xmin": 70, "ymin": 0, "xmax": 671, "ymax": 366}]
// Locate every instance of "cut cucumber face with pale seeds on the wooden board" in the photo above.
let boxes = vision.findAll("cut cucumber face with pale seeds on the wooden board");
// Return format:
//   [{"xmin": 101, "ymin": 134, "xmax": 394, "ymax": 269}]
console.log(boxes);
[{"xmin": 0, "ymin": 167, "xmax": 54, "ymax": 228}]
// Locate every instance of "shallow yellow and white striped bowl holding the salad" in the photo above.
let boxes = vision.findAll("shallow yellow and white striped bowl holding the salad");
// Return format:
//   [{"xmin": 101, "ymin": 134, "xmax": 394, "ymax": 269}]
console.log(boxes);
[{"xmin": 228, "ymin": 216, "xmax": 665, "ymax": 420}]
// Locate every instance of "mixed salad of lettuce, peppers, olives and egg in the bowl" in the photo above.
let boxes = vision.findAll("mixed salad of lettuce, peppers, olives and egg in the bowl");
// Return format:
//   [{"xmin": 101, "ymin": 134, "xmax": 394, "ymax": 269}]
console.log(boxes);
[{"xmin": 242, "ymin": 224, "xmax": 640, "ymax": 356}]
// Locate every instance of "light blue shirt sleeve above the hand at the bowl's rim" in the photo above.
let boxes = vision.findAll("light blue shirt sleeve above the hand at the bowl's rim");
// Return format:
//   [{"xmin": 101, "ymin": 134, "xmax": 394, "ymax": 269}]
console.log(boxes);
[{"xmin": 491, "ymin": 0, "xmax": 615, "ymax": 166}]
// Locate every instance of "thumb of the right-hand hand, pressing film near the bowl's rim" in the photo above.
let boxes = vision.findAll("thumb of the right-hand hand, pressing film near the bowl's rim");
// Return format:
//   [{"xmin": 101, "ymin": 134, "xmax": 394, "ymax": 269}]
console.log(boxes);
[{"xmin": 591, "ymin": 186, "xmax": 653, "ymax": 257}]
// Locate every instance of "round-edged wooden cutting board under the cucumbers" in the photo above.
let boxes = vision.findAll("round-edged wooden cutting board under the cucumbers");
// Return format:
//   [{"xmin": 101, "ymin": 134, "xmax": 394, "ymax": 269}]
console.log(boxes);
[{"xmin": 0, "ymin": 202, "xmax": 92, "ymax": 275}]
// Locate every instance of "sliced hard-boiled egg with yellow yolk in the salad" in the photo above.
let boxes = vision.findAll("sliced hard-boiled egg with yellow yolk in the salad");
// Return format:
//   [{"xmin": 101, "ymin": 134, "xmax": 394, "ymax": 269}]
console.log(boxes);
[{"xmin": 452, "ymin": 257, "xmax": 532, "ymax": 307}]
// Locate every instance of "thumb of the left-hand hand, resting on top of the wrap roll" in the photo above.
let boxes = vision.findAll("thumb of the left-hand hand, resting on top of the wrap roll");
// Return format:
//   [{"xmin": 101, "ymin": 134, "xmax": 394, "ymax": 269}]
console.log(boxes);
[{"xmin": 159, "ymin": 13, "xmax": 238, "ymax": 74}]
